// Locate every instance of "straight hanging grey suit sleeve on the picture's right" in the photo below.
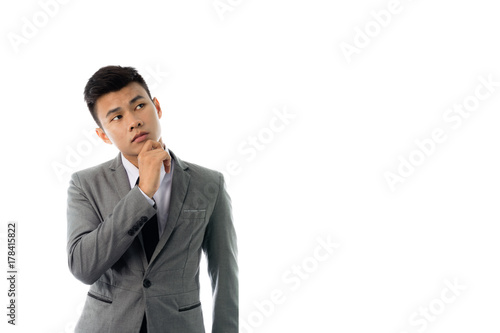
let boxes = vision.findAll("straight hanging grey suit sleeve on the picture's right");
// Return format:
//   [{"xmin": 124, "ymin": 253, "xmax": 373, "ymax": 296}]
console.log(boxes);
[{"xmin": 203, "ymin": 174, "xmax": 239, "ymax": 333}]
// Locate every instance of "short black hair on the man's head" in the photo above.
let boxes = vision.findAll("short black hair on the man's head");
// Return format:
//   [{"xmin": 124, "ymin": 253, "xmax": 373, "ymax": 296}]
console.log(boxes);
[{"xmin": 83, "ymin": 66, "xmax": 152, "ymax": 128}]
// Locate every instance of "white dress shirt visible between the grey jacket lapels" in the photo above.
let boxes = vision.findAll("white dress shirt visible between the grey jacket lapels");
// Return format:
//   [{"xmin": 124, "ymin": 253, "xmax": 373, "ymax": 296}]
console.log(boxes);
[{"xmin": 121, "ymin": 148, "xmax": 174, "ymax": 237}]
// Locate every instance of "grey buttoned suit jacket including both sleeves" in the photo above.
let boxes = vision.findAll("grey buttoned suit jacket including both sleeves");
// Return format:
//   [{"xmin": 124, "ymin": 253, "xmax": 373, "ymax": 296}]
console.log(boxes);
[{"xmin": 67, "ymin": 151, "xmax": 238, "ymax": 333}]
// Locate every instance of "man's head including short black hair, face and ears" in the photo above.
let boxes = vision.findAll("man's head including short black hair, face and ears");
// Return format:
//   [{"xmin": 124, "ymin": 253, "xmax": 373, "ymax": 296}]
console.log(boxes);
[{"xmin": 84, "ymin": 66, "xmax": 162, "ymax": 164}]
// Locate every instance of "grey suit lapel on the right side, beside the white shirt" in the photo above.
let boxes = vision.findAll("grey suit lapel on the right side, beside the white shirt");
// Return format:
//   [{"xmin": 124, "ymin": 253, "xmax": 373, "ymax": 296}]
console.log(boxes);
[{"xmin": 151, "ymin": 150, "xmax": 191, "ymax": 263}]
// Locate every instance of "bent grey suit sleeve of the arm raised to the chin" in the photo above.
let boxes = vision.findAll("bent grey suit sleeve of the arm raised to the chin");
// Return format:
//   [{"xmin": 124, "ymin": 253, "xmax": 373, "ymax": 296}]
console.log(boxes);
[{"xmin": 67, "ymin": 174, "xmax": 156, "ymax": 284}]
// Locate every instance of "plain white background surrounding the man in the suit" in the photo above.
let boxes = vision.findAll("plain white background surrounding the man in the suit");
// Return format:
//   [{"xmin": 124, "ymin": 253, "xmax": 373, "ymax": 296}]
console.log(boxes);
[{"xmin": 0, "ymin": 0, "xmax": 500, "ymax": 333}]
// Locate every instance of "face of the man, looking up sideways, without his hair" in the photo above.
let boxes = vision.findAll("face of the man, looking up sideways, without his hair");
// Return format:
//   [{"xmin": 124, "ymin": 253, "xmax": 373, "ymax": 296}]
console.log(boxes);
[{"xmin": 95, "ymin": 82, "xmax": 163, "ymax": 166}]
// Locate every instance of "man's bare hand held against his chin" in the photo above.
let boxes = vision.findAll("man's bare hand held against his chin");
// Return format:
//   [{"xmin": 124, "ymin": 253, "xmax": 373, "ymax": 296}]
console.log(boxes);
[{"xmin": 137, "ymin": 140, "xmax": 170, "ymax": 198}]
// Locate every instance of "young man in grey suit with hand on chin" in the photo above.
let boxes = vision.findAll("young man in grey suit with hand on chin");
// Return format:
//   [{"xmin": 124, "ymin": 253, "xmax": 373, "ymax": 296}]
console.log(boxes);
[{"xmin": 67, "ymin": 66, "xmax": 238, "ymax": 333}]
